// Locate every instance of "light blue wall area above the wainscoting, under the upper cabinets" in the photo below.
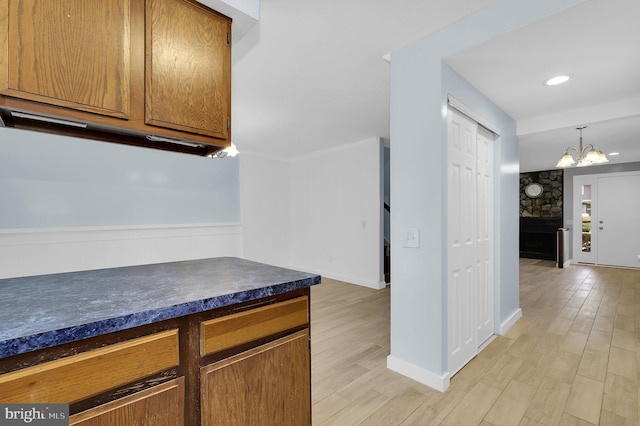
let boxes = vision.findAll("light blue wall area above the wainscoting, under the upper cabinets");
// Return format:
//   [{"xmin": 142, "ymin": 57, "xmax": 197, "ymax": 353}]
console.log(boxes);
[{"xmin": 0, "ymin": 128, "xmax": 240, "ymax": 229}]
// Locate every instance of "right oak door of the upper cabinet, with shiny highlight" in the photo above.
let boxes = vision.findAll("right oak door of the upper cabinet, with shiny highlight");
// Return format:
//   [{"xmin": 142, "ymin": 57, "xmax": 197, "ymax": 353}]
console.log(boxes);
[{"xmin": 145, "ymin": 0, "xmax": 231, "ymax": 139}]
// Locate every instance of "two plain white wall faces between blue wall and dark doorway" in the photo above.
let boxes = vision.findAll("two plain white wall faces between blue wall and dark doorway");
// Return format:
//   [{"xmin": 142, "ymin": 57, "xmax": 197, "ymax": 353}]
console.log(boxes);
[{"xmin": 240, "ymin": 138, "xmax": 385, "ymax": 288}]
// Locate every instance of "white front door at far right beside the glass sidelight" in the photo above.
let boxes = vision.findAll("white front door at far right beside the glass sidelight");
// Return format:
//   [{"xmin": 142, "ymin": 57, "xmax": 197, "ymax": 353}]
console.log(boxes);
[{"xmin": 592, "ymin": 173, "xmax": 640, "ymax": 268}]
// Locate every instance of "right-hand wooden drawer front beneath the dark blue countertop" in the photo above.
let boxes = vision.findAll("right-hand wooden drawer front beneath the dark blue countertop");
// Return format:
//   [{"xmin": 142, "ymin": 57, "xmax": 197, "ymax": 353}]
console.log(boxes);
[{"xmin": 200, "ymin": 296, "xmax": 309, "ymax": 356}]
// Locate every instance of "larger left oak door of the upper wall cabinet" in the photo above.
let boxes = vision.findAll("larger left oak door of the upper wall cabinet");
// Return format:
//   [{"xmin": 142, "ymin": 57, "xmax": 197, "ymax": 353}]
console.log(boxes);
[{"xmin": 0, "ymin": 0, "xmax": 130, "ymax": 118}]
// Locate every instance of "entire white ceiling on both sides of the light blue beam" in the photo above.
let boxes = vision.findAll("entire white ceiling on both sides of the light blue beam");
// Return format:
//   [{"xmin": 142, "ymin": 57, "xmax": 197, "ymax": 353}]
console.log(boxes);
[{"xmin": 232, "ymin": 0, "xmax": 640, "ymax": 171}]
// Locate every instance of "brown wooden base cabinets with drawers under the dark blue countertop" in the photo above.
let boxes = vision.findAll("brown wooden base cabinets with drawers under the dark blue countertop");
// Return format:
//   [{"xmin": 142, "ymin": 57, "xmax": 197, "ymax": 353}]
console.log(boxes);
[{"xmin": 0, "ymin": 289, "xmax": 311, "ymax": 426}]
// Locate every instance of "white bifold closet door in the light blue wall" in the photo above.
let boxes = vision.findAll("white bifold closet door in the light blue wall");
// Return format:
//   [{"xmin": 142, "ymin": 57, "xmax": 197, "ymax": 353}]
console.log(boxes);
[{"xmin": 447, "ymin": 108, "xmax": 494, "ymax": 375}]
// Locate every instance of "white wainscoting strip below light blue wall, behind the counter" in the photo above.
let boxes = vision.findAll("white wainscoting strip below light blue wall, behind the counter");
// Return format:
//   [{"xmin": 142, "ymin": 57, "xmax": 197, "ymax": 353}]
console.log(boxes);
[{"xmin": 0, "ymin": 223, "xmax": 242, "ymax": 278}]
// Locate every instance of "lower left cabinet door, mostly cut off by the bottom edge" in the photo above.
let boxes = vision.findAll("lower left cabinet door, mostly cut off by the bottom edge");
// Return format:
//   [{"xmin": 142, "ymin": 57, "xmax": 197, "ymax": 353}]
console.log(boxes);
[{"xmin": 69, "ymin": 377, "xmax": 184, "ymax": 426}]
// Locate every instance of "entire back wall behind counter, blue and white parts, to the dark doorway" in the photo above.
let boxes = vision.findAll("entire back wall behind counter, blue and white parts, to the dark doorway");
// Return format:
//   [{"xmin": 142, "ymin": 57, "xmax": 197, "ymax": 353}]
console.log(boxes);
[{"xmin": 0, "ymin": 124, "xmax": 384, "ymax": 282}]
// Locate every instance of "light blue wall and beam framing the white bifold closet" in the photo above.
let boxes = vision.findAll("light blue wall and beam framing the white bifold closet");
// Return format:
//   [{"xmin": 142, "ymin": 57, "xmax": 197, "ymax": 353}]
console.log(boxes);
[{"xmin": 390, "ymin": 0, "xmax": 581, "ymax": 384}]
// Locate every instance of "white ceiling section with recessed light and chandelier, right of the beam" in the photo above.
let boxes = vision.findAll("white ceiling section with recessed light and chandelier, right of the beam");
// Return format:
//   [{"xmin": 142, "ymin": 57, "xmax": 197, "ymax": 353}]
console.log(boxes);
[{"xmin": 446, "ymin": 0, "xmax": 640, "ymax": 172}]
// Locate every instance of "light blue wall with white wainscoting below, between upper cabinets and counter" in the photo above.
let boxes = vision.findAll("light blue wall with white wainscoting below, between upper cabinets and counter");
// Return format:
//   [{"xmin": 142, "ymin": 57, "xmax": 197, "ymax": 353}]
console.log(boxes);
[{"xmin": 0, "ymin": 128, "xmax": 242, "ymax": 278}]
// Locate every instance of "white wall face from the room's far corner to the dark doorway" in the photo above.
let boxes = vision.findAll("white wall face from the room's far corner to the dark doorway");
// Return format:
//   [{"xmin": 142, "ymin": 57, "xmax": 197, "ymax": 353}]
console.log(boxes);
[{"xmin": 290, "ymin": 138, "xmax": 385, "ymax": 288}]
